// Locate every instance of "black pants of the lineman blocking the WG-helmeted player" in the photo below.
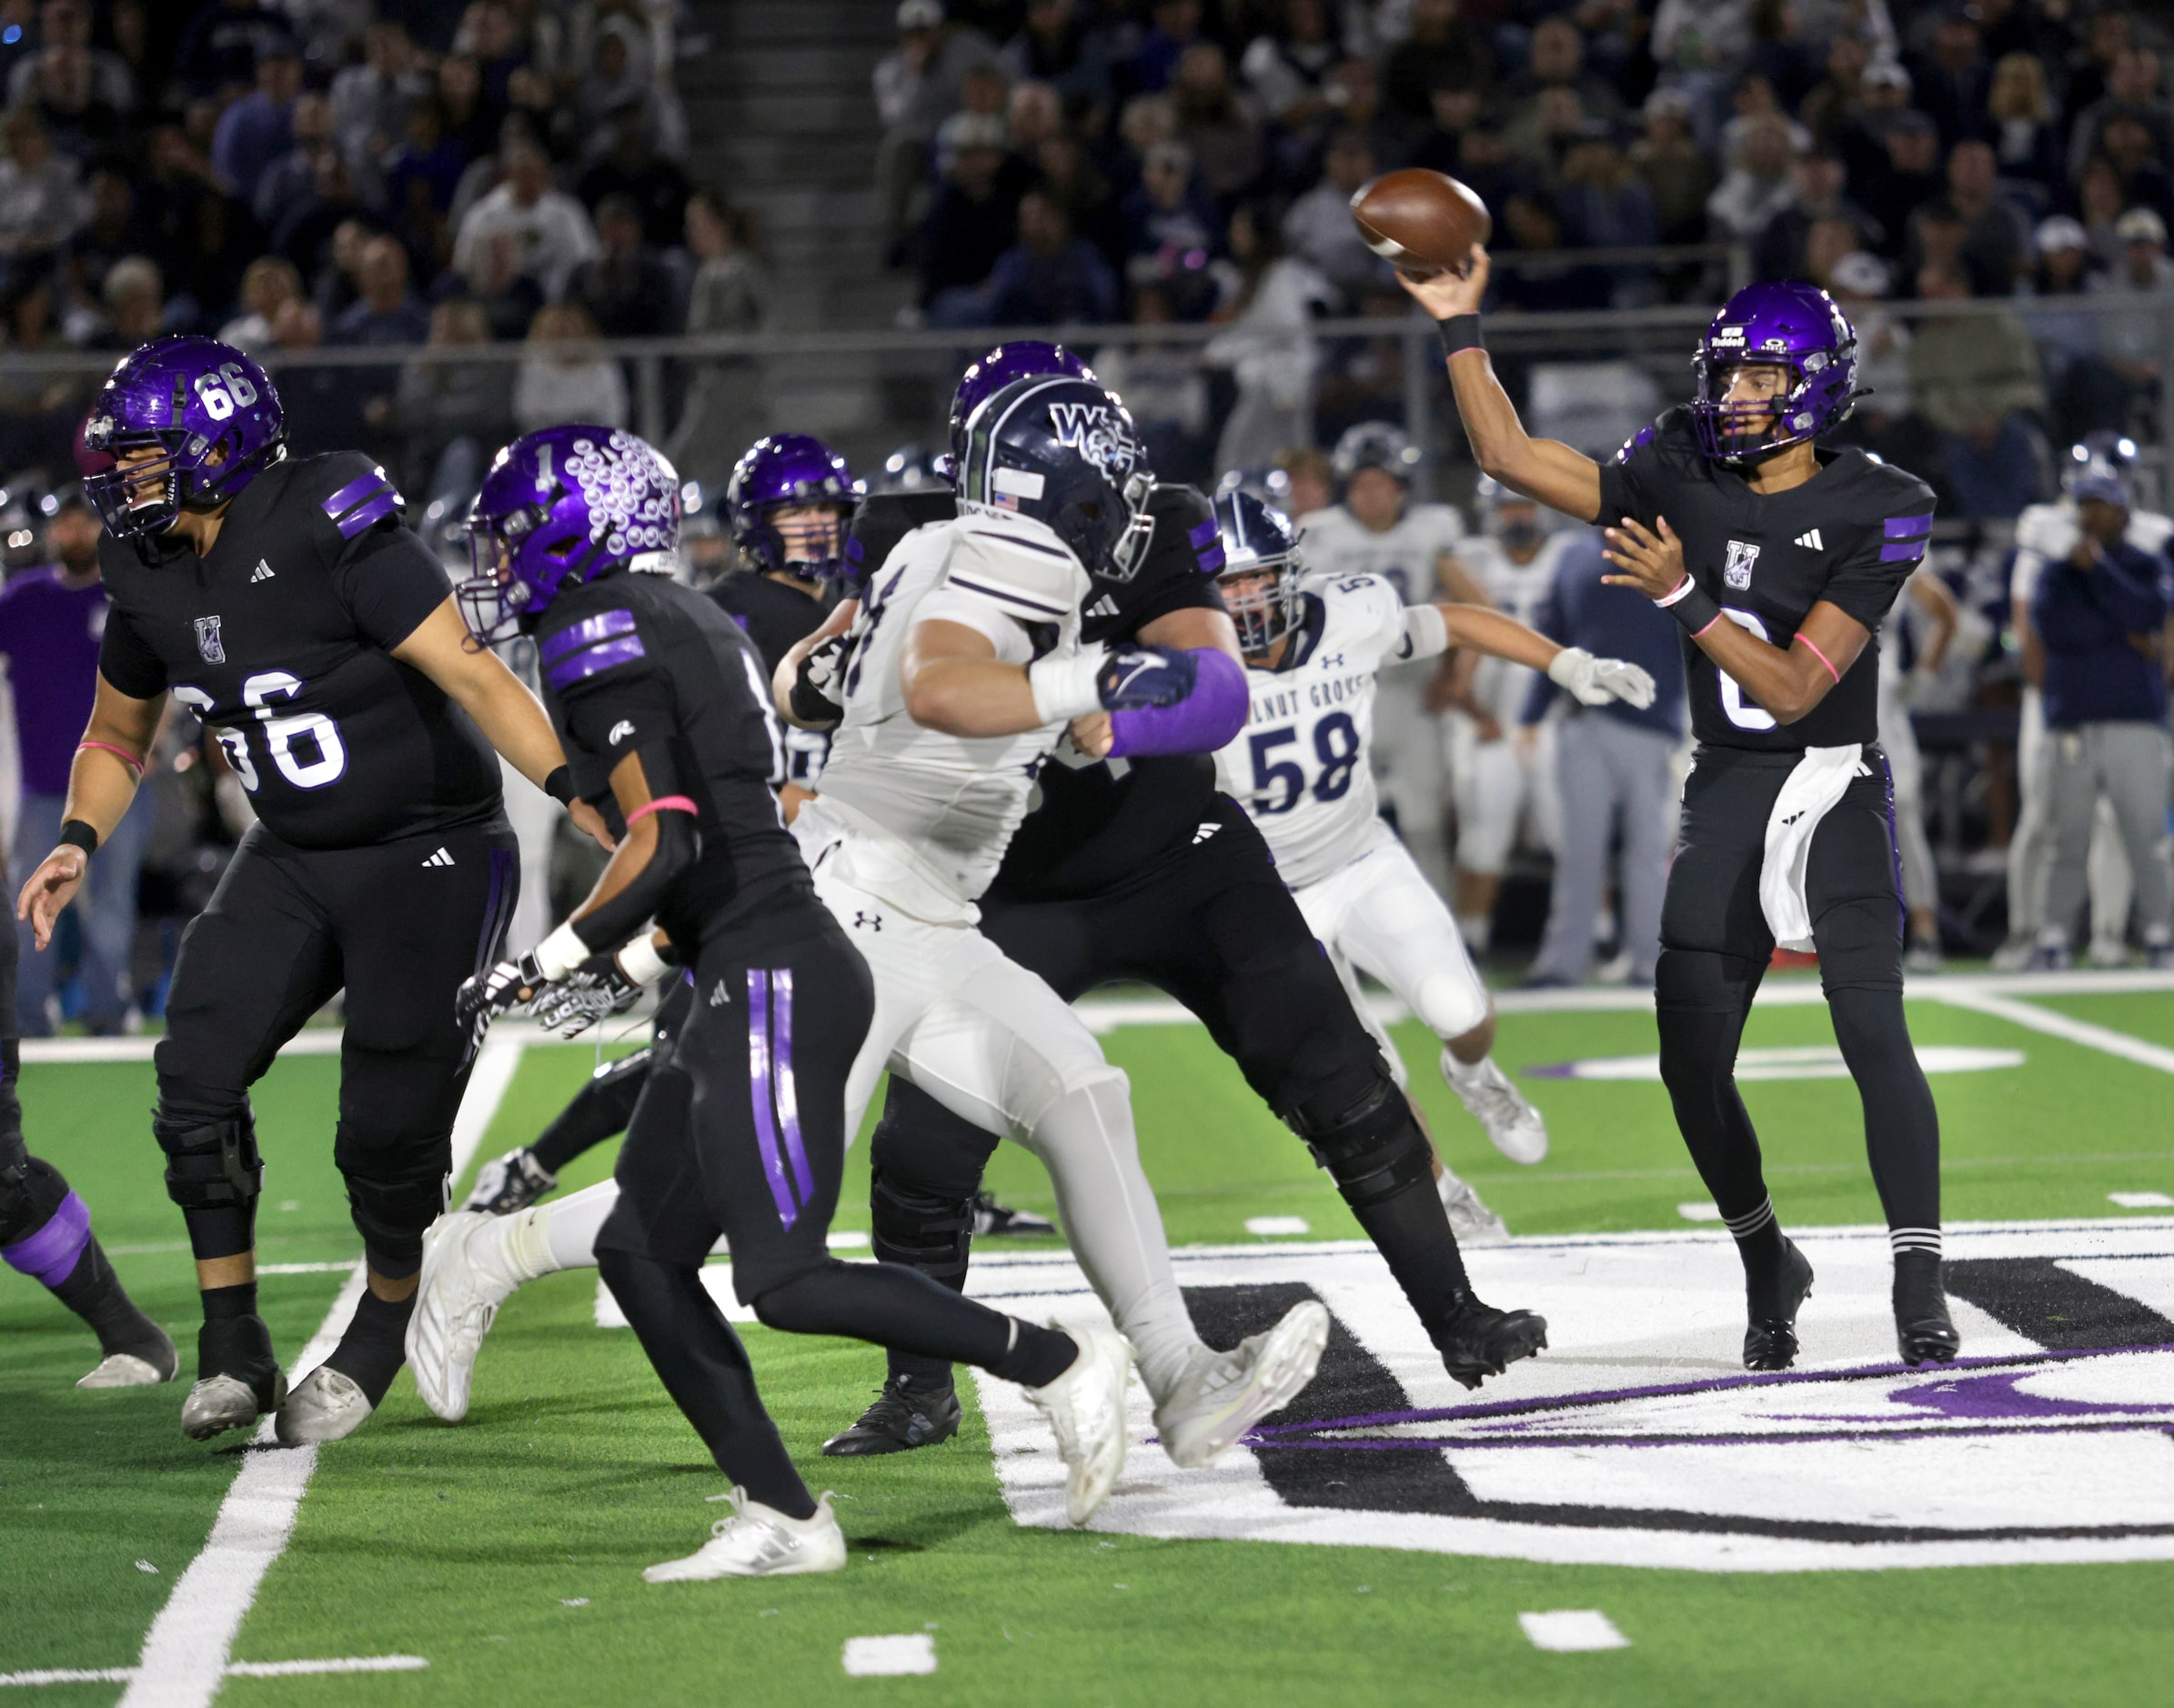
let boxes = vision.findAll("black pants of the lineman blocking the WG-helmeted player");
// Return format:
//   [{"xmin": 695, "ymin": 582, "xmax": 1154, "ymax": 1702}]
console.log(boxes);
[{"xmin": 870, "ymin": 795, "xmax": 1434, "ymax": 1386}]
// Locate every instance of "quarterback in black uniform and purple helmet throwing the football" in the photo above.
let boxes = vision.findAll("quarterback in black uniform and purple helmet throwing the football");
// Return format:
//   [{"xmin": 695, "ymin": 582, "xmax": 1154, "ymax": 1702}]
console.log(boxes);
[{"xmin": 1404, "ymin": 263, "xmax": 1958, "ymax": 1369}]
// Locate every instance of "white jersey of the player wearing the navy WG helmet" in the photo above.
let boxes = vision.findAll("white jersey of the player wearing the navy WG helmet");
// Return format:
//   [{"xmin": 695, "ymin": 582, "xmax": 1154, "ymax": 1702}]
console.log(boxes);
[{"xmin": 820, "ymin": 510, "xmax": 1089, "ymax": 913}]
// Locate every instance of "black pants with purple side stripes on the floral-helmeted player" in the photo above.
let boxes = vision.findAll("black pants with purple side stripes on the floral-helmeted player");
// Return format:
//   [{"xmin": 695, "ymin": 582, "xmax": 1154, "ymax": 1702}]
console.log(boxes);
[{"xmin": 596, "ymin": 902, "xmax": 1074, "ymax": 1517}]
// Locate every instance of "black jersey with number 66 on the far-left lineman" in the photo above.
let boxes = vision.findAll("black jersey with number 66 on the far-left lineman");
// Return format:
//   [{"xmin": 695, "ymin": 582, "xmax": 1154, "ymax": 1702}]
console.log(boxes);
[{"xmin": 98, "ymin": 452, "xmax": 502, "ymax": 848}]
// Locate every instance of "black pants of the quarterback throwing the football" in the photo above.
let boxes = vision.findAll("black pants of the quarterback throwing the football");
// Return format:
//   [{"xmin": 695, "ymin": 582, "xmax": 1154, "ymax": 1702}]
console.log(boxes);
[{"xmin": 1655, "ymin": 748, "xmax": 1939, "ymax": 1247}]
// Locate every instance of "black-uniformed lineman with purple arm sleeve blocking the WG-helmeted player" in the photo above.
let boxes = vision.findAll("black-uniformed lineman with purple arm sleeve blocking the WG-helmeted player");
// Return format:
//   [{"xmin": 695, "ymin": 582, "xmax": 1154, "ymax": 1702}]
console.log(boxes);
[{"xmin": 824, "ymin": 344, "xmax": 1545, "ymax": 1456}]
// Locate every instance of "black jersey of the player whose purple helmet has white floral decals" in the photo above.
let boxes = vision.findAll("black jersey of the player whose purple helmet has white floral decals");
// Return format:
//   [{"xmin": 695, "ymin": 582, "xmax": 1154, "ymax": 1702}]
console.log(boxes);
[{"xmin": 535, "ymin": 571, "xmax": 820, "ymax": 943}]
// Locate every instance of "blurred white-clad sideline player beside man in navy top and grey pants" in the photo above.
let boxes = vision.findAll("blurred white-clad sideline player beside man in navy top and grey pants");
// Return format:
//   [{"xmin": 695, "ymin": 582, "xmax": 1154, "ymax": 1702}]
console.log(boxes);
[{"xmin": 1448, "ymin": 476, "xmax": 1578, "ymax": 954}]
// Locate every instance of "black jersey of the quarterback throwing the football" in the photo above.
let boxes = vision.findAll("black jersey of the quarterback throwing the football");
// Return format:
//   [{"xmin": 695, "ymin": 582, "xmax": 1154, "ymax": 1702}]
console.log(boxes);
[{"xmin": 1600, "ymin": 408, "xmax": 1933, "ymax": 752}]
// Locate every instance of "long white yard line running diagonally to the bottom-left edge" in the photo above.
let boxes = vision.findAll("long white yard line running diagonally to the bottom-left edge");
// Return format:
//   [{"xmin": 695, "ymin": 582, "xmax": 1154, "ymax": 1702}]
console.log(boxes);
[{"xmin": 122, "ymin": 1037, "xmax": 522, "ymax": 1708}]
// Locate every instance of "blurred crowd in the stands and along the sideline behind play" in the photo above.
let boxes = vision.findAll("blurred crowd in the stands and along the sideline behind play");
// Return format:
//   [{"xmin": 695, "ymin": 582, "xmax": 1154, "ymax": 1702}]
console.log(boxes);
[{"xmin": 0, "ymin": 0, "xmax": 2174, "ymax": 1030}]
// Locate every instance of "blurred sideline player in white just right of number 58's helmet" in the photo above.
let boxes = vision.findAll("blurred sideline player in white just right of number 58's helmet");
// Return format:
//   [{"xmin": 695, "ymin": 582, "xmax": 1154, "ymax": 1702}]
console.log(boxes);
[{"xmin": 1292, "ymin": 422, "xmax": 1485, "ymax": 895}]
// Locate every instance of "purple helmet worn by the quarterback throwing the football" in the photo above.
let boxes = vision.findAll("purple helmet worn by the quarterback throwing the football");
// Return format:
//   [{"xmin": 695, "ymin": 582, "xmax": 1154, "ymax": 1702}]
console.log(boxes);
[{"xmin": 1691, "ymin": 280, "xmax": 1858, "ymax": 463}]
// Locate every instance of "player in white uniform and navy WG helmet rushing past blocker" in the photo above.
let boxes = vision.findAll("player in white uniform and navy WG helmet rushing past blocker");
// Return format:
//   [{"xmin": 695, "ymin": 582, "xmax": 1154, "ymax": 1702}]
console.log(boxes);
[{"xmin": 415, "ymin": 378, "xmax": 1328, "ymax": 1467}]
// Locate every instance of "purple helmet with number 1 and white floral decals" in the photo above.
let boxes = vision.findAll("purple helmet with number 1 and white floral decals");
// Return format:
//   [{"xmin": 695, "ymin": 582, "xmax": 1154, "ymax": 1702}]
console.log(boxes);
[{"xmin": 452, "ymin": 424, "xmax": 680, "ymax": 646}]
